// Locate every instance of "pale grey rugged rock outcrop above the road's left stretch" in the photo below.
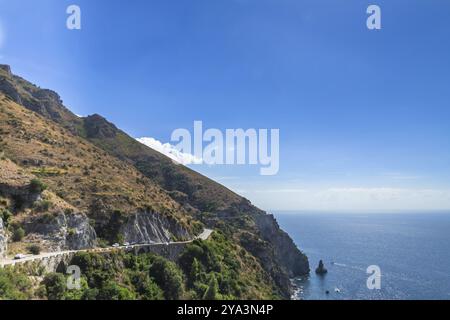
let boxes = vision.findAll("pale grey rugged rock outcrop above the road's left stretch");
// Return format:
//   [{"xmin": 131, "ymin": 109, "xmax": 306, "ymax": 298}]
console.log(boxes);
[{"xmin": 24, "ymin": 213, "xmax": 97, "ymax": 251}]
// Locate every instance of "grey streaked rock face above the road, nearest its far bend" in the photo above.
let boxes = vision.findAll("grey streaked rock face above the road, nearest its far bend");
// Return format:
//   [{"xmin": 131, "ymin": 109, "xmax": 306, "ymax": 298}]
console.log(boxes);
[{"xmin": 121, "ymin": 212, "xmax": 192, "ymax": 243}]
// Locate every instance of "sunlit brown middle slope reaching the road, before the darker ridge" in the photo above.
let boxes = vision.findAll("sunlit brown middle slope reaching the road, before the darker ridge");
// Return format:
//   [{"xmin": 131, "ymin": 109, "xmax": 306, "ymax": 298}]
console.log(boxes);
[{"xmin": 0, "ymin": 94, "xmax": 201, "ymax": 242}]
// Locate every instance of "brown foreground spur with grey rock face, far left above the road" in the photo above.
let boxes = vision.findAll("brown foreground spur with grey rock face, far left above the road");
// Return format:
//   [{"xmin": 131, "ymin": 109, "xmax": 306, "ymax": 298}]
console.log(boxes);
[{"xmin": 0, "ymin": 156, "xmax": 97, "ymax": 252}]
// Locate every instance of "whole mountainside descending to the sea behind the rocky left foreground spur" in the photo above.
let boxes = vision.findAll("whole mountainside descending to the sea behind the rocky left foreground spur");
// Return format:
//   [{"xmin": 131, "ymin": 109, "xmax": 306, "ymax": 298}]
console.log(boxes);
[{"xmin": 0, "ymin": 65, "xmax": 309, "ymax": 297}]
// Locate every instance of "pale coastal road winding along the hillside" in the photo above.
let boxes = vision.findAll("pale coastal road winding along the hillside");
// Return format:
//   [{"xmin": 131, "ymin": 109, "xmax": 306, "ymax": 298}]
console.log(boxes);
[{"xmin": 0, "ymin": 229, "xmax": 213, "ymax": 268}]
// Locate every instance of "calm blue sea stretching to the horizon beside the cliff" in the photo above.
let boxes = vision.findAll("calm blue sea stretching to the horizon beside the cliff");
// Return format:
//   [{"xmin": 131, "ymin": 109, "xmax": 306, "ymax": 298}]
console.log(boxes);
[{"xmin": 275, "ymin": 212, "xmax": 450, "ymax": 300}]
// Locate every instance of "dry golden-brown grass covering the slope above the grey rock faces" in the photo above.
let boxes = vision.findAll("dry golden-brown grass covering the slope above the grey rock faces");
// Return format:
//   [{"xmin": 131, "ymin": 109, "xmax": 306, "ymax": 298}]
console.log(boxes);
[{"xmin": 0, "ymin": 95, "xmax": 195, "ymax": 230}]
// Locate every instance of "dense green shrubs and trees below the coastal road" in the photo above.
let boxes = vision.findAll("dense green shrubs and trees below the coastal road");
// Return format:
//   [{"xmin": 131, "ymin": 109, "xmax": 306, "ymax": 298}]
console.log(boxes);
[{"xmin": 0, "ymin": 233, "xmax": 277, "ymax": 300}]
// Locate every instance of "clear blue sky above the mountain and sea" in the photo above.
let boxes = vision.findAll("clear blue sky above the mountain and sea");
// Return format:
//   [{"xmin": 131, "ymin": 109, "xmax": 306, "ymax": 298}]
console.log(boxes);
[{"xmin": 0, "ymin": 0, "xmax": 450, "ymax": 211}]
